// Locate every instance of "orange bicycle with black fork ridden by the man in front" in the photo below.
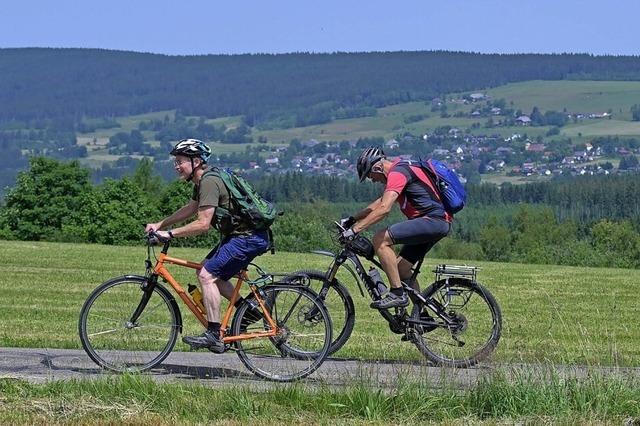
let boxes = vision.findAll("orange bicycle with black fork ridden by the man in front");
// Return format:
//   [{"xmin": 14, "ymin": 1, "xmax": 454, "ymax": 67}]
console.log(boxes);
[{"xmin": 78, "ymin": 234, "xmax": 332, "ymax": 382}]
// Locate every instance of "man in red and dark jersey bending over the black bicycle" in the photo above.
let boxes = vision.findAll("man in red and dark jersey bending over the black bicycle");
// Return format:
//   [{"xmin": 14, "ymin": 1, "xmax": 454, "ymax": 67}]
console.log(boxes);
[{"xmin": 341, "ymin": 147, "xmax": 452, "ymax": 309}]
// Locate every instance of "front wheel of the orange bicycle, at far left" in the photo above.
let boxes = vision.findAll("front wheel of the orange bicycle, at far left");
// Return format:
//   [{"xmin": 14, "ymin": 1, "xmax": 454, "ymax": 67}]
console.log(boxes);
[{"xmin": 78, "ymin": 276, "xmax": 181, "ymax": 372}]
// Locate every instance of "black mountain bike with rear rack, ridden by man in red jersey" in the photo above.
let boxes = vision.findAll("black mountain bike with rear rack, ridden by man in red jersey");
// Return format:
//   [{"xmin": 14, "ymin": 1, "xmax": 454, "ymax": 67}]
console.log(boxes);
[{"xmin": 285, "ymin": 222, "xmax": 502, "ymax": 367}]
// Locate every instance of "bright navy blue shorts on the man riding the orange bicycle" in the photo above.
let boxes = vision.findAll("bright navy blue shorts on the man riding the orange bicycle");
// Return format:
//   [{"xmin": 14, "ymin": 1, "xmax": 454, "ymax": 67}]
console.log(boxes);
[{"xmin": 203, "ymin": 231, "xmax": 269, "ymax": 280}]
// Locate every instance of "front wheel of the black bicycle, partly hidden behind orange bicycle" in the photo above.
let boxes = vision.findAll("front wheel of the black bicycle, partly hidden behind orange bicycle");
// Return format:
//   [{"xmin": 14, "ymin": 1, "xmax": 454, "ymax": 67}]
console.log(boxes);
[{"xmin": 283, "ymin": 269, "xmax": 356, "ymax": 355}]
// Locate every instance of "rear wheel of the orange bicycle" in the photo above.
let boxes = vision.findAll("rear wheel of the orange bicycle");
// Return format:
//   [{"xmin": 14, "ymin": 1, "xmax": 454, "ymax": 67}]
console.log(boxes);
[{"xmin": 231, "ymin": 284, "xmax": 331, "ymax": 382}]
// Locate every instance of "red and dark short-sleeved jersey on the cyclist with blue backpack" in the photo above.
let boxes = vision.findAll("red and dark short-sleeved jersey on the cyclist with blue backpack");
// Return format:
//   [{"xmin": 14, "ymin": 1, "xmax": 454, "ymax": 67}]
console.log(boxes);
[{"xmin": 384, "ymin": 160, "xmax": 451, "ymax": 222}]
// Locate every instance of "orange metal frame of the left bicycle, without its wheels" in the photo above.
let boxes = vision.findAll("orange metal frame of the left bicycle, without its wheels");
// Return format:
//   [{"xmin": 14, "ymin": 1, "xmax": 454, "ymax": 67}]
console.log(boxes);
[{"xmin": 144, "ymin": 241, "xmax": 278, "ymax": 343}]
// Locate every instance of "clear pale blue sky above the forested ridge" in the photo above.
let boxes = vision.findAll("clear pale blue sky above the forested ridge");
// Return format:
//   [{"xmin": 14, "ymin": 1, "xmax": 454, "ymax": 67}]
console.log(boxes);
[{"xmin": 0, "ymin": 0, "xmax": 640, "ymax": 55}]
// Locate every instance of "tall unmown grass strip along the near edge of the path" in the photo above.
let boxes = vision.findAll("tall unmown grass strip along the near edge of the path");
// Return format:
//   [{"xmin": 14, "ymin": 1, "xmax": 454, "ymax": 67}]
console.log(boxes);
[{"xmin": 0, "ymin": 370, "xmax": 640, "ymax": 424}]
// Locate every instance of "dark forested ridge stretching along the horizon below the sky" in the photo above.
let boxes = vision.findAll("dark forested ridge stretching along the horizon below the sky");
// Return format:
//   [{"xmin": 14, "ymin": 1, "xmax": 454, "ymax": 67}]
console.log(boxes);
[{"xmin": 0, "ymin": 48, "xmax": 640, "ymax": 126}]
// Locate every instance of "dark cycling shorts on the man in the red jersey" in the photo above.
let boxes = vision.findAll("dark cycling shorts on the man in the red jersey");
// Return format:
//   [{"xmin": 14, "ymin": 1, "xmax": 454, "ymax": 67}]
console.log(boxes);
[{"xmin": 387, "ymin": 217, "xmax": 451, "ymax": 263}]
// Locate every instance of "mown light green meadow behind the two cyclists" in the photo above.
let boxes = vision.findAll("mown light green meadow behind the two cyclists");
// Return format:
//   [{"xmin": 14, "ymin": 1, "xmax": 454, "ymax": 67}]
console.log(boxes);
[{"xmin": 0, "ymin": 241, "xmax": 640, "ymax": 366}]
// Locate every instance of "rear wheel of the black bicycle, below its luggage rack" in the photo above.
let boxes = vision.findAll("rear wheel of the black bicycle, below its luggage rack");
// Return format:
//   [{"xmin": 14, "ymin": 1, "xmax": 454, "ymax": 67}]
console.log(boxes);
[{"xmin": 411, "ymin": 278, "xmax": 502, "ymax": 368}]
